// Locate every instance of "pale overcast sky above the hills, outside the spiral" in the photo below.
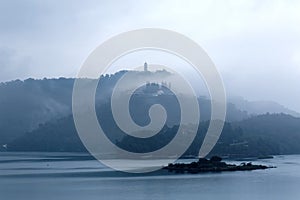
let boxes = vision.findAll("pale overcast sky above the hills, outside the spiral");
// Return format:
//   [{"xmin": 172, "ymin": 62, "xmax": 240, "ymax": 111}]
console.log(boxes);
[{"xmin": 0, "ymin": 0, "xmax": 300, "ymax": 112}]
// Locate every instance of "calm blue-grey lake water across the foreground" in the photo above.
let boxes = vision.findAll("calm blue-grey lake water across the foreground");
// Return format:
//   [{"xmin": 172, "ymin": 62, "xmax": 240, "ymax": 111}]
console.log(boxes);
[{"xmin": 0, "ymin": 153, "xmax": 300, "ymax": 200}]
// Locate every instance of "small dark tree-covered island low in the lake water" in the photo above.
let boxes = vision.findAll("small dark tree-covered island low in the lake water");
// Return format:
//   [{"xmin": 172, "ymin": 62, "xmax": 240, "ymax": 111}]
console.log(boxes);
[{"xmin": 163, "ymin": 156, "xmax": 274, "ymax": 174}]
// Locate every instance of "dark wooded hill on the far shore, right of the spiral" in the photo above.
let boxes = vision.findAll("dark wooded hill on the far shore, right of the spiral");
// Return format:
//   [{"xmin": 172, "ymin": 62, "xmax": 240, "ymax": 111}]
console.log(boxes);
[{"xmin": 212, "ymin": 113, "xmax": 300, "ymax": 157}]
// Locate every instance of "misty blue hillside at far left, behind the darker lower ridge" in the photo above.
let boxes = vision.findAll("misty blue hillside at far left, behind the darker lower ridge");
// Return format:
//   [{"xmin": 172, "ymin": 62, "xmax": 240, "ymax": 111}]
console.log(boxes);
[{"xmin": 0, "ymin": 78, "xmax": 74, "ymax": 144}]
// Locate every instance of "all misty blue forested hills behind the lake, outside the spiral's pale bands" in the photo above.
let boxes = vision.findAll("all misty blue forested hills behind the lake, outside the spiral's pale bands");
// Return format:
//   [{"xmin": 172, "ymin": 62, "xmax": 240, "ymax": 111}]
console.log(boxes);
[{"xmin": 0, "ymin": 71, "xmax": 300, "ymax": 157}]
